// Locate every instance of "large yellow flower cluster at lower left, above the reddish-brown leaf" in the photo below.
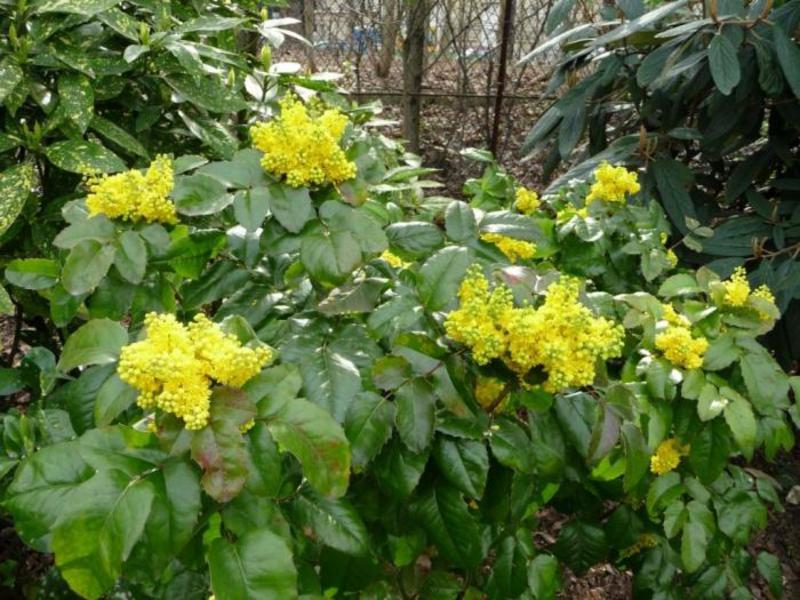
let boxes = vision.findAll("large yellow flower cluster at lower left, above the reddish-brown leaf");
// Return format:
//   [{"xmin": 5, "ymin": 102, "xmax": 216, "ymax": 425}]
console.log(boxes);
[{"xmin": 117, "ymin": 313, "xmax": 274, "ymax": 429}]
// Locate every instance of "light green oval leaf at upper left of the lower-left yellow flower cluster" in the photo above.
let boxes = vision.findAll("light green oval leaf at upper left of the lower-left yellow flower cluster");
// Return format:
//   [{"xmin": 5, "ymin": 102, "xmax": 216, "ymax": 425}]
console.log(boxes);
[{"xmin": 58, "ymin": 319, "xmax": 128, "ymax": 373}]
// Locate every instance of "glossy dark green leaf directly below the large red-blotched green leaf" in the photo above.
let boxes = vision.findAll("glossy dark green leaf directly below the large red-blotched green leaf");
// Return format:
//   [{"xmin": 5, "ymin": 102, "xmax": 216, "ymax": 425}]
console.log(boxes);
[{"xmin": 291, "ymin": 493, "xmax": 370, "ymax": 556}]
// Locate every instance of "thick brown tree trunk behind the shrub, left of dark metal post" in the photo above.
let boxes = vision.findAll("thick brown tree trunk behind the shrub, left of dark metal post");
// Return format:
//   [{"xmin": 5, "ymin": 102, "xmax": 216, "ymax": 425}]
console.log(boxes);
[{"xmin": 403, "ymin": 0, "xmax": 430, "ymax": 152}]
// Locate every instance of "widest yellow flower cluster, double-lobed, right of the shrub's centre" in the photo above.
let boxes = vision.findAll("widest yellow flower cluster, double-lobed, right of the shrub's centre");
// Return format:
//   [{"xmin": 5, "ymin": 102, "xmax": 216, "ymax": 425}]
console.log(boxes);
[{"xmin": 445, "ymin": 265, "xmax": 624, "ymax": 392}]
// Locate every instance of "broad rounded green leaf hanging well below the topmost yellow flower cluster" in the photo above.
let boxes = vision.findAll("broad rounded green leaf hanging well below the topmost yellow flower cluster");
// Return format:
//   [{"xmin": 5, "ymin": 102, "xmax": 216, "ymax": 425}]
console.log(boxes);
[{"xmin": 300, "ymin": 229, "xmax": 361, "ymax": 286}]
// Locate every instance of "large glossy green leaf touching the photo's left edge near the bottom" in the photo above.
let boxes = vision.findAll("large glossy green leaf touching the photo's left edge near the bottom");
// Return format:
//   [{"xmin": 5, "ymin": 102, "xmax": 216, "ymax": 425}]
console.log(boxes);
[{"xmin": 3, "ymin": 441, "xmax": 94, "ymax": 552}]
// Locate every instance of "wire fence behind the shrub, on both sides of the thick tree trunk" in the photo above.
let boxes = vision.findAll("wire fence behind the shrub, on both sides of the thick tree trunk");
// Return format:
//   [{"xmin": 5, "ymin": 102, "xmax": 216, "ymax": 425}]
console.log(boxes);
[{"xmin": 277, "ymin": 0, "xmax": 554, "ymax": 176}]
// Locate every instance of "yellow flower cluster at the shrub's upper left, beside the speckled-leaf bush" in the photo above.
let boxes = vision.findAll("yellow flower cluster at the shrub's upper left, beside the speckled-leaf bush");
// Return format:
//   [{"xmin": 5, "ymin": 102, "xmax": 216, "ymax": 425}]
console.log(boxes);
[{"xmin": 86, "ymin": 155, "xmax": 178, "ymax": 223}]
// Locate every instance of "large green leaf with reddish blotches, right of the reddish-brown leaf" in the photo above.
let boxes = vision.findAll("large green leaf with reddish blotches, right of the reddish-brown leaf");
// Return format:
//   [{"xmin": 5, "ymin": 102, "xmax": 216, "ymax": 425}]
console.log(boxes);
[{"xmin": 268, "ymin": 398, "xmax": 350, "ymax": 497}]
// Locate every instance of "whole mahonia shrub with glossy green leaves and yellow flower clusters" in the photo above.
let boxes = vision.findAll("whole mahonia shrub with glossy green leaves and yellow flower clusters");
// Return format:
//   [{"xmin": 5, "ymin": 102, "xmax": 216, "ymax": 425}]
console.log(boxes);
[{"xmin": 0, "ymin": 94, "xmax": 800, "ymax": 600}]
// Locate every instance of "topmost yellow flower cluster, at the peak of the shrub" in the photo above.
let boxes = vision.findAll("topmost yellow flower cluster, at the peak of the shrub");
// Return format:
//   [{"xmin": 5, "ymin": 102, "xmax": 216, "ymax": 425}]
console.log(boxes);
[{"xmin": 250, "ymin": 96, "xmax": 356, "ymax": 187}]
